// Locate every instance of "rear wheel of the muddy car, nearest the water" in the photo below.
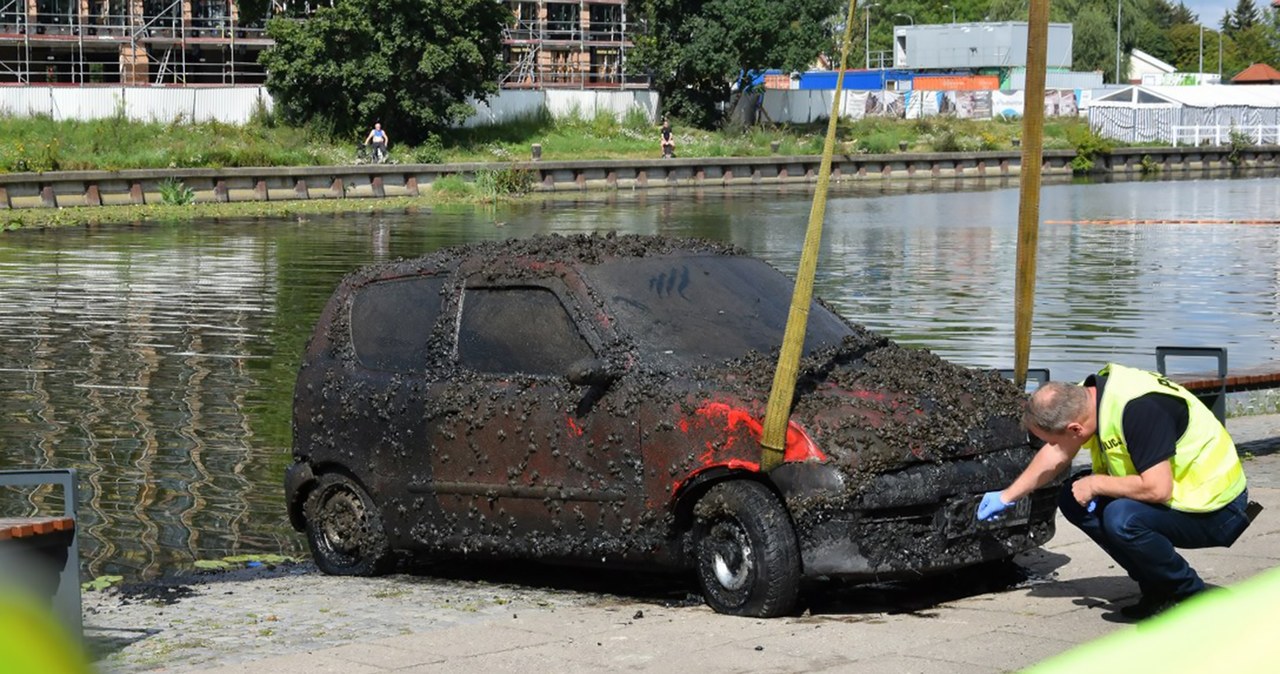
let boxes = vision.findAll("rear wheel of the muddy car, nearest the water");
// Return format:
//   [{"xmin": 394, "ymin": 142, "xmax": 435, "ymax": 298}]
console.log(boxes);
[{"xmin": 305, "ymin": 473, "xmax": 393, "ymax": 576}]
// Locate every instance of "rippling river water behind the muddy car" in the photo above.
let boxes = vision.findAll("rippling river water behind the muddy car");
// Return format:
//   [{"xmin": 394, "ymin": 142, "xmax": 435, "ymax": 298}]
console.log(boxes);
[{"xmin": 0, "ymin": 178, "xmax": 1280, "ymax": 578}]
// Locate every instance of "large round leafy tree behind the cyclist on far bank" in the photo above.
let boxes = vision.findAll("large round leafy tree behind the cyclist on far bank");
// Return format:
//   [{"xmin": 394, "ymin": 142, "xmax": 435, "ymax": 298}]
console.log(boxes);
[{"xmin": 260, "ymin": 0, "xmax": 512, "ymax": 142}]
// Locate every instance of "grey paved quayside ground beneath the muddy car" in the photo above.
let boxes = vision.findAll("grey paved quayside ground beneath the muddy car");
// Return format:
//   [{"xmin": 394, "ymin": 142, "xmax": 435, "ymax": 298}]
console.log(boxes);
[{"xmin": 84, "ymin": 416, "xmax": 1280, "ymax": 674}]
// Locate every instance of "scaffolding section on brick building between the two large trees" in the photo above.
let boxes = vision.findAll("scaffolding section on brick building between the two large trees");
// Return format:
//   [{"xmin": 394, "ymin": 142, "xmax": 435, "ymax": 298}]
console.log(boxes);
[{"xmin": 500, "ymin": 0, "xmax": 649, "ymax": 88}]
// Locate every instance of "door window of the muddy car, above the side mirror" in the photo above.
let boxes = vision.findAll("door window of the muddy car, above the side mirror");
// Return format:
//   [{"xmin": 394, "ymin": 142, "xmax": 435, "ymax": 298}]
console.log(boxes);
[{"xmin": 458, "ymin": 286, "xmax": 593, "ymax": 376}]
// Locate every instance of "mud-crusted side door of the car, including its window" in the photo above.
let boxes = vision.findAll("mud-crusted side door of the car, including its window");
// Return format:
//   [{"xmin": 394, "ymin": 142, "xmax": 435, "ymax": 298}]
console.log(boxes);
[{"xmin": 430, "ymin": 272, "xmax": 640, "ymax": 560}]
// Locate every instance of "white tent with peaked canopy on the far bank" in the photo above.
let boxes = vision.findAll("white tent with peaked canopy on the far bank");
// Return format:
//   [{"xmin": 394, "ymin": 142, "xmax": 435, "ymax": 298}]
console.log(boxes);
[{"xmin": 1089, "ymin": 84, "xmax": 1280, "ymax": 145}]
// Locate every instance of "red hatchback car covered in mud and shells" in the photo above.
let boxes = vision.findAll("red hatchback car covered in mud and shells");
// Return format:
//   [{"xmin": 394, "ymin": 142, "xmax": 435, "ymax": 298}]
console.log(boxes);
[{"xmin": 285, "ymin": 235, "xmax": 1053, "ymax": 616}]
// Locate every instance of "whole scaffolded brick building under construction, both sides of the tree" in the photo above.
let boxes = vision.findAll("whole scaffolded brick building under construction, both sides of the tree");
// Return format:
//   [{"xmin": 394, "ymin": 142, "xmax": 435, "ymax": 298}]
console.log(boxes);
[{"xmin": 0, "ymin": 0, "xmax": 648, "ymax": 88}]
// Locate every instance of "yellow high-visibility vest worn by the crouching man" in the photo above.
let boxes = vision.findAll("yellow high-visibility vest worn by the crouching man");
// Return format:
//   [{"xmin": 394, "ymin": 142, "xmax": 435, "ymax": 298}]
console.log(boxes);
[{"xmin": 1084, "ymin": 363, "xmax": 1244, "ymax": 513}]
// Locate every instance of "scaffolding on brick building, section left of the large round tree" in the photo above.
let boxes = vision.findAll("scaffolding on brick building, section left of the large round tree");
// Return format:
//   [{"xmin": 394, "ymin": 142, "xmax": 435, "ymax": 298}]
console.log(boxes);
[{"xmin": 0, "ymin": 0, "xmax": 271, "ymax": 86}]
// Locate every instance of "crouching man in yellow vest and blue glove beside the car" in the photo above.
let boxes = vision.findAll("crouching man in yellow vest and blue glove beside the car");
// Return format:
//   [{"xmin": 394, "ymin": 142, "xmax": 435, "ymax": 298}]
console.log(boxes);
[{"xmin": 977, "ymin": 363, "xmax": 1253, "ymax": 619}]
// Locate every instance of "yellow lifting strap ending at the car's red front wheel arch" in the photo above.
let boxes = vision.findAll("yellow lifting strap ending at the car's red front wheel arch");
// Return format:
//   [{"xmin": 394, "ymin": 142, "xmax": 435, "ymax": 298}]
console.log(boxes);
[{"xmin": 760, "ymin": 0, "xmax": 858, "ymax": 471}]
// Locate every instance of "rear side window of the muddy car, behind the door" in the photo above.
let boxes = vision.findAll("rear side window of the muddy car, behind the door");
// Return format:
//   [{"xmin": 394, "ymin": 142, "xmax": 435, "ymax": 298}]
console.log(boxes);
[{"xmin": 351, "ymin": 276, "xmax": 444, "ymax": 372}]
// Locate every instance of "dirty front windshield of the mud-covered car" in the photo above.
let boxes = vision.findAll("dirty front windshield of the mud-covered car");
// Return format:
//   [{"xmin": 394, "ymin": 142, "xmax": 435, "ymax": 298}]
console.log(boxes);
[{"xmin": 584, "ymin": 255, "xmax": 851, "ymax": 367}]
